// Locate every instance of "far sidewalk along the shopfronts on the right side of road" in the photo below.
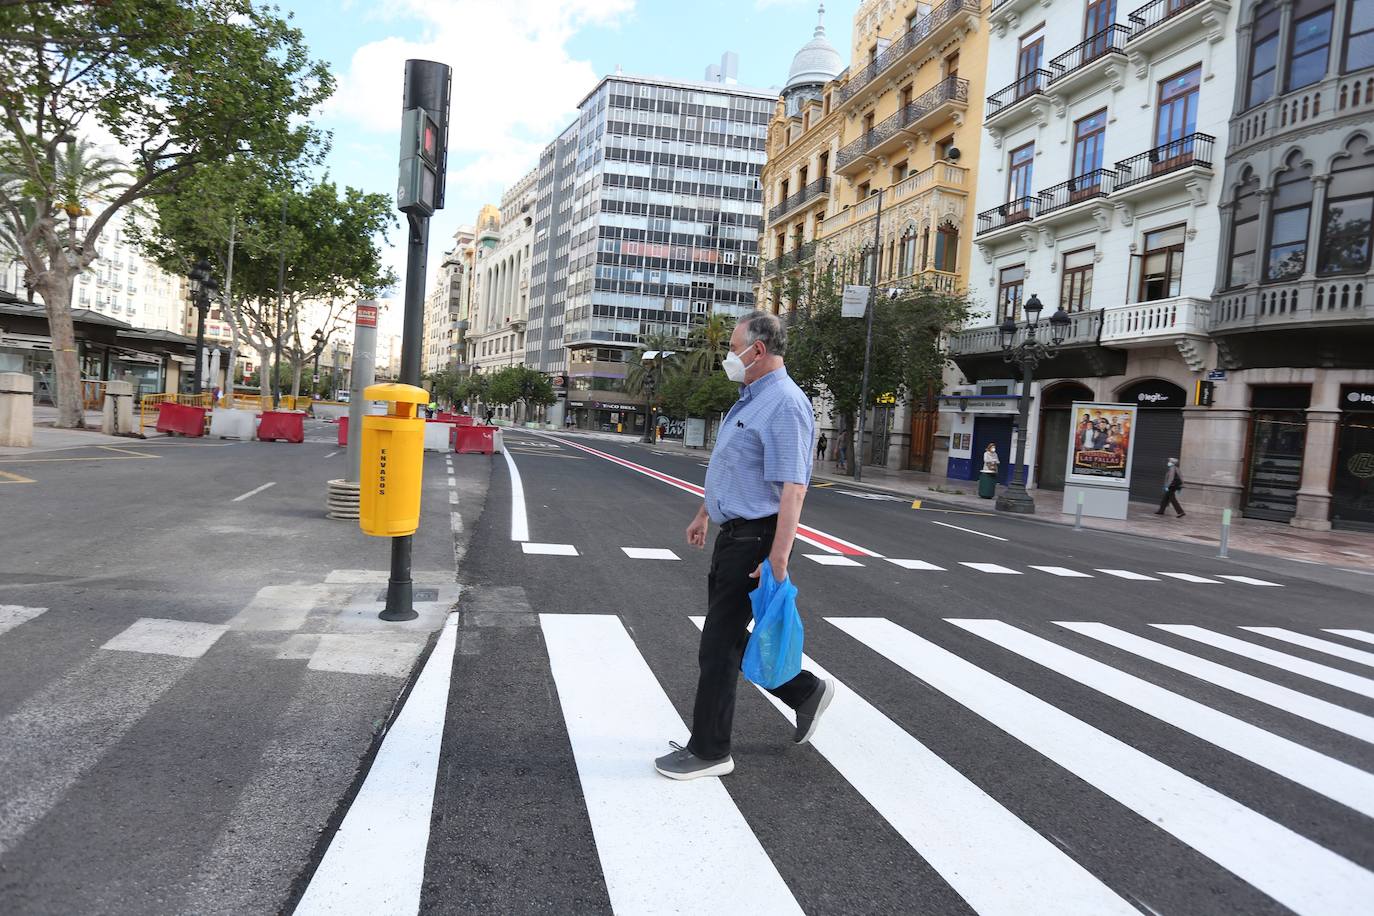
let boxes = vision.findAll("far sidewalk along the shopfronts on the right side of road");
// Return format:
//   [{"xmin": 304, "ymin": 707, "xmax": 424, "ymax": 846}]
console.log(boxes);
[{"xmin": 560, "ymin": 431, "xmax": 1374, "ymax": 573}]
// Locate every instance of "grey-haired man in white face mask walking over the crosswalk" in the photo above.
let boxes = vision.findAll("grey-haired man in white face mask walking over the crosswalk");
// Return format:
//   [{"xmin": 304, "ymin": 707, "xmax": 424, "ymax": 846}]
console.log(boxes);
[{"xmin": 654, "ymin": 312, "xmax": 835, "ymax": 779}]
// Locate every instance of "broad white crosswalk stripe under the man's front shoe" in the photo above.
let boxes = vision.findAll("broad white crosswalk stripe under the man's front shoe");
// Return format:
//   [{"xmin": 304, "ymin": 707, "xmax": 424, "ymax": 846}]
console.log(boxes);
[{"xmin": 541, "ymin": 614, "xmax": 801, "ymax": 915}]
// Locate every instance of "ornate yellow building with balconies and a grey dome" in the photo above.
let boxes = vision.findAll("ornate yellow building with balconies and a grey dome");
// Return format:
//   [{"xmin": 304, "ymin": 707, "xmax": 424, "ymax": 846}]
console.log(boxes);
[{"xmin": 757, "ymin": 0, "xmax": 988, "ymax": 467}]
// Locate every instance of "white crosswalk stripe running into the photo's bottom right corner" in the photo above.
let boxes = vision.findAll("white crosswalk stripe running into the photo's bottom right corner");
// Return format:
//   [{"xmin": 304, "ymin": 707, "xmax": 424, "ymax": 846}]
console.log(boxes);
[{"xmin": 826, "ymin": 618, "xmax": 1374, "ymax": 916}]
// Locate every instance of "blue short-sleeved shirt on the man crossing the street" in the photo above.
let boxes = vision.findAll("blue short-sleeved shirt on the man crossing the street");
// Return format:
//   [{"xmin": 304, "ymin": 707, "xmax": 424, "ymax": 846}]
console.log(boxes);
[{"xmin": 706, "ymin": 368, "xmax": 816, "ymax": 525}]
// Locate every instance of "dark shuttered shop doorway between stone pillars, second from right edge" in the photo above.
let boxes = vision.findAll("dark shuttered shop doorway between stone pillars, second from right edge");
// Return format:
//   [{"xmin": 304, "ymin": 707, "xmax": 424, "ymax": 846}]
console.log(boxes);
[{"xmin": 1242, "ymin": 385, "xmax": 1312, "ymax": 522}]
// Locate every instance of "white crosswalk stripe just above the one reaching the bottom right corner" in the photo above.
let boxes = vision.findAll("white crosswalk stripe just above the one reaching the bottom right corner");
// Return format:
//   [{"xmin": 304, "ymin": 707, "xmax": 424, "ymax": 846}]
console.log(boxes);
[{"xmin": 947, "ymin": 618, "xmax": 1374, "ymax": 817}]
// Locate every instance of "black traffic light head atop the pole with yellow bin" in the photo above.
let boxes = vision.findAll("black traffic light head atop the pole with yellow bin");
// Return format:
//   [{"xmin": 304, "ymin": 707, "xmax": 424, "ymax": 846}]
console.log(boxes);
[{"xmin": 396, "ymin": 60, "xmax": 453, "ymax": 216}]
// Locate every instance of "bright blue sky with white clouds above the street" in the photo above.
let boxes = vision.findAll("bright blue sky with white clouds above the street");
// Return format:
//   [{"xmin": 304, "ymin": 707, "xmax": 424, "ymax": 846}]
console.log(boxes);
[{"xmin": 270, "ymin": 0, "xmax": 859, "ymax": 334}]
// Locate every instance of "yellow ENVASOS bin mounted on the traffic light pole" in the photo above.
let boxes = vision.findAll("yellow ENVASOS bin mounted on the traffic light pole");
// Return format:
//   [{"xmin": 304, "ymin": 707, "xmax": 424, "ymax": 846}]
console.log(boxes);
[{"xmin": 357, "ymin": 385, "xmax": 430, "ymax": 537}]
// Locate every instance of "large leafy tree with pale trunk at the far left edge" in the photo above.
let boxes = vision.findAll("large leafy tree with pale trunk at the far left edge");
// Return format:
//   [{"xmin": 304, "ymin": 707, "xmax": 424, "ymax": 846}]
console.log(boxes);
[{"xmin": 0, "ymin": 0, "xmax": 334, "ymax": 427}]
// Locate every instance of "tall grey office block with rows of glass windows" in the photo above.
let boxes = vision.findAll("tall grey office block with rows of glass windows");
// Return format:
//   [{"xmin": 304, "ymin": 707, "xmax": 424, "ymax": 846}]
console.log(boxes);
[{"xmin": 525, "ymin": 55, "xmax": 776, "ymax": 431}]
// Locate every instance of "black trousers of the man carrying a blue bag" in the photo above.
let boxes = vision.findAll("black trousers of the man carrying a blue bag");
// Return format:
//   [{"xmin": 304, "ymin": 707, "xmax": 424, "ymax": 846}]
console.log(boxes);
[{"xmin": 687, "ymin": 515, "xmax": 820, "ymax": 759}]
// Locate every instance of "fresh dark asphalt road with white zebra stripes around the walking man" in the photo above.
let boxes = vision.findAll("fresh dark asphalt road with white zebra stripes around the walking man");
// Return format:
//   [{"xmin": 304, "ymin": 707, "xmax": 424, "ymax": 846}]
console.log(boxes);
[{"xmin": 420, "ymin": 434, "xmax": 1374, "ymax": 915}]
